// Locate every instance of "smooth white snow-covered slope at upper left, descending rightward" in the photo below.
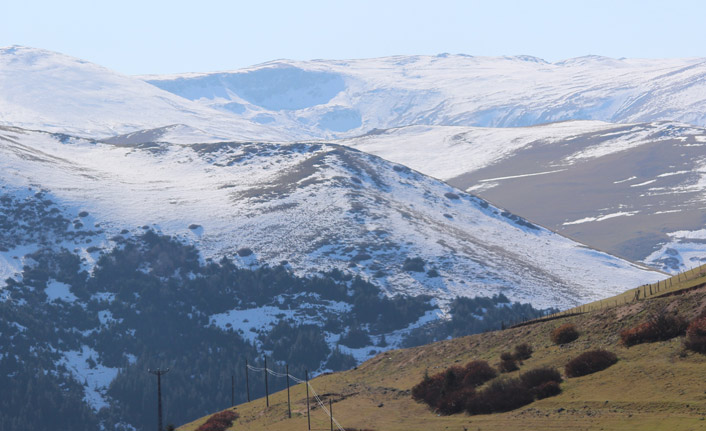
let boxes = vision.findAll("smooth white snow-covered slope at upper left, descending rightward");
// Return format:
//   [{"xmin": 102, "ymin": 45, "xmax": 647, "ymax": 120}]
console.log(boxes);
[{"xmin": 0, "ymin": 46, "xmax": 288, "ymax": 141}]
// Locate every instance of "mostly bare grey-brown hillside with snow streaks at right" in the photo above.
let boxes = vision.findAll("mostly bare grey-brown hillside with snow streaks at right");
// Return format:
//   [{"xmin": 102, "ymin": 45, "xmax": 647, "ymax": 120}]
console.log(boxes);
[{"xmin": 341, "ymin": 121, "xmax": 706, "ymax": 272}]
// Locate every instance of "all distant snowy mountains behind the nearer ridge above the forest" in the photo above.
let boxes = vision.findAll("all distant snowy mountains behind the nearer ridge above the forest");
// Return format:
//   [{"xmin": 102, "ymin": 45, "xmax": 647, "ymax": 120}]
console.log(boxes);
[{"xmin": 0, "ymin": 47, "xmax": 706, "ymax": 272}]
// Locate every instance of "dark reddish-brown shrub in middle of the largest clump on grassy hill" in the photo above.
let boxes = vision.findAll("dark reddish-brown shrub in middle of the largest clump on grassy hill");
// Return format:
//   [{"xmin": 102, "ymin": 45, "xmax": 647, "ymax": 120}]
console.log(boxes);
[{"xmin": 466, "ymin": 379, "xmax": 534, "ymax": 415}]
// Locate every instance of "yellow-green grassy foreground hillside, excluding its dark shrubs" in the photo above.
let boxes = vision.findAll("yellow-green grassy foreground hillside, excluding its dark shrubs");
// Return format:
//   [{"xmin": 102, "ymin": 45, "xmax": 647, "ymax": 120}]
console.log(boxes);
[{"xmin": 179, "ymin": 287, "xmax": 706, "ymax": 431}]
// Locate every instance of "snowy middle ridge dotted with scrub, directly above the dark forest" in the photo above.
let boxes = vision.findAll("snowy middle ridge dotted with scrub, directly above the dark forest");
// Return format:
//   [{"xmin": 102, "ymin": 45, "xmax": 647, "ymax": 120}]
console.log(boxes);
[{"xmin": 0, "ymin": 128, "xmax": 661, "ymax": 306}]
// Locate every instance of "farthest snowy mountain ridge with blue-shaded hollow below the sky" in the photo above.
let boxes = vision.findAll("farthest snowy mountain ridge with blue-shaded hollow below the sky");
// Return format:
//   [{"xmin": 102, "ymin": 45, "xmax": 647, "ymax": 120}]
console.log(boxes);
[{"xmin": 143, "ymin": 55, "xmax": 706, "ymax": 137}]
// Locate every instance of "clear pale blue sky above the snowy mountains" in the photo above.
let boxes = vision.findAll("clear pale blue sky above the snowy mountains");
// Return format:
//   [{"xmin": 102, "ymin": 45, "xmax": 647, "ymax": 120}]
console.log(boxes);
[{"xmin": 0, "ymin": 0, "xmax": 706, "ymax": 74}]
